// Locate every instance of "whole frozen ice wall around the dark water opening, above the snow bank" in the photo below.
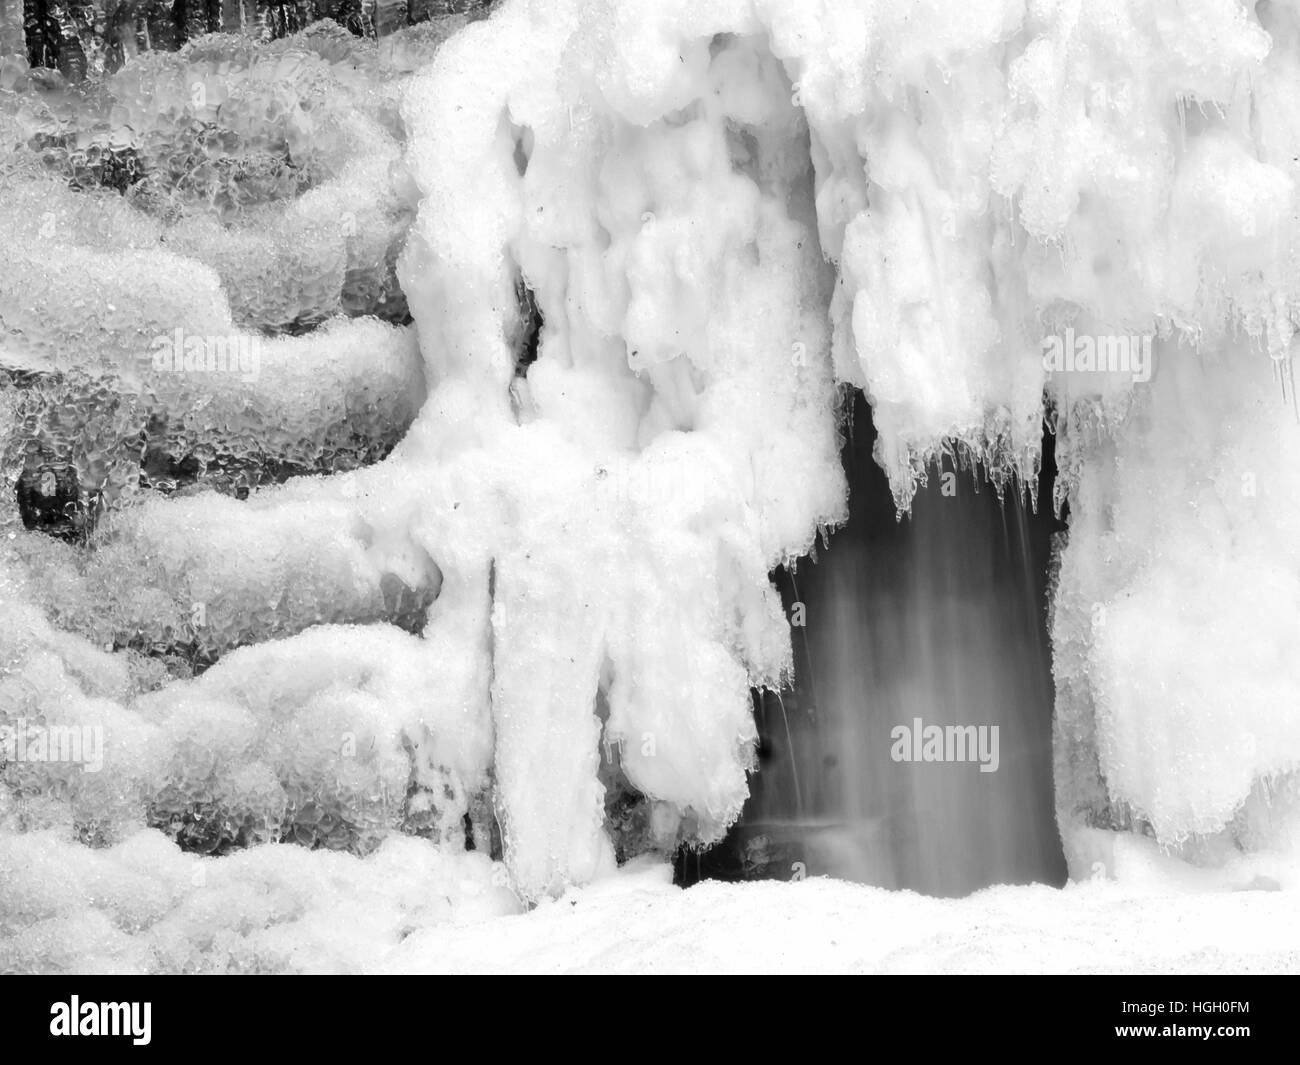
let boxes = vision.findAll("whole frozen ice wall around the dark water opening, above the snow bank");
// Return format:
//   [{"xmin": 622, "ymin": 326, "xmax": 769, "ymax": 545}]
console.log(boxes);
[{"xmin": 0, "ymin": 0, "xmax": 1300, "ymax": 966}]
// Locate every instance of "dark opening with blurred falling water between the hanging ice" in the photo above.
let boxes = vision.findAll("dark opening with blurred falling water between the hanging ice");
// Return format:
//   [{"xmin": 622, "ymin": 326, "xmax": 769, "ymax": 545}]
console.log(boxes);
[{"xmin": 677, "ymin": 398, "xmax": 1066, "ymax": 896}]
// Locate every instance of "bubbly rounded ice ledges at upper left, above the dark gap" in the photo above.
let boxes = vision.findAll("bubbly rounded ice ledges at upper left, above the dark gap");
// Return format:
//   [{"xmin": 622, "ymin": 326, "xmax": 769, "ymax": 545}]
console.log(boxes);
[{"xmin": 0, "ymin": 20, "xmax": 436, "ymax": 523}]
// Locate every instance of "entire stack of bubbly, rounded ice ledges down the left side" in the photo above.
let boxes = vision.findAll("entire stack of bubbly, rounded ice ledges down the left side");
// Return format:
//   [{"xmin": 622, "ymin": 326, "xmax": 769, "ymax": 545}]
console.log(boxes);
[{"xmin": 0, "ymin": 20, "xmax": 506, "ymax": 971}]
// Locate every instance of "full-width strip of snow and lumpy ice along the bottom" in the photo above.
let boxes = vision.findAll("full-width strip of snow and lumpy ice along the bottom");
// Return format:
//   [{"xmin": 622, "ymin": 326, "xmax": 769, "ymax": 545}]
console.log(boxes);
[{"xmin": 0, "ymin": 847, "xmax": 1300, "ymax": 974}]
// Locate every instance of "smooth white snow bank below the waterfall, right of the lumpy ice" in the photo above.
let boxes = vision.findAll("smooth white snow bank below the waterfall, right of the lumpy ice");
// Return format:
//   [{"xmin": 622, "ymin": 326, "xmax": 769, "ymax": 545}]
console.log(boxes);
[{"xmin": 378, "ymin": 866, "xmax": 1300, "ymax": 974}]
